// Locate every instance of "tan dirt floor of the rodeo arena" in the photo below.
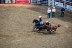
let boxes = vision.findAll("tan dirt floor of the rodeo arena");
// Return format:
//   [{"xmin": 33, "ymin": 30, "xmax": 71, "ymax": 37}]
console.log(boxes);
[{"xmin": 0, "ymin": 4, "xmax": 72, "ymax": 48}]
